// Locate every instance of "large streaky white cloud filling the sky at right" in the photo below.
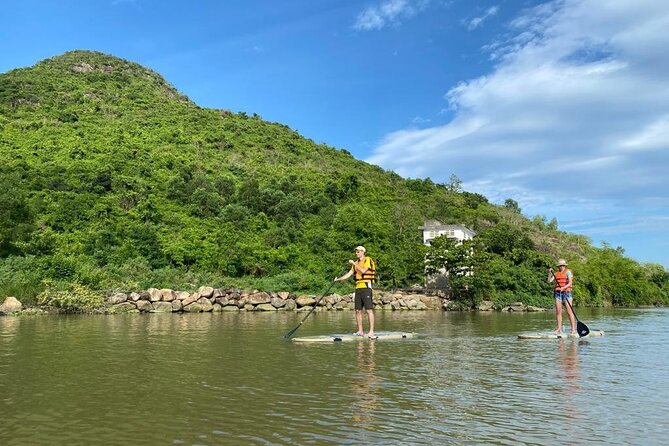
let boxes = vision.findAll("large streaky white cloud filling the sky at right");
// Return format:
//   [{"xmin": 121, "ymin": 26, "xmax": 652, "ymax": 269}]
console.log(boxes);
[{"xmin": 367, "ymin": 0, "xmax": 669, "ymax": 262}]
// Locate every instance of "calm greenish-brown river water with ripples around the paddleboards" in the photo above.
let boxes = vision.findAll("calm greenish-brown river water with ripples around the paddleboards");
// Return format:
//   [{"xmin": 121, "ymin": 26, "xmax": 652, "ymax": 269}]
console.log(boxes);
[{"xmin": 0, "ymin": 309, "xmax": 669, "ymax": 446}]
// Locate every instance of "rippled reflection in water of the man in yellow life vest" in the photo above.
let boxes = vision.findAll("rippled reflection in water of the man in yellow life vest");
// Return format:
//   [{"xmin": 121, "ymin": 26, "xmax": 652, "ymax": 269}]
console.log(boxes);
[{"xmin": 351, "ymin": 341, "xmax": 381, "ymax": 428}]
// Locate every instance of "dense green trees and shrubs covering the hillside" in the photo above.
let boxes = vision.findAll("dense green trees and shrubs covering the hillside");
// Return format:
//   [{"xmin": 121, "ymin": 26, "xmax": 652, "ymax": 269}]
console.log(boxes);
[{"xmin": 0, "ymin": 51, "xmax": 669, "ymax": 305}]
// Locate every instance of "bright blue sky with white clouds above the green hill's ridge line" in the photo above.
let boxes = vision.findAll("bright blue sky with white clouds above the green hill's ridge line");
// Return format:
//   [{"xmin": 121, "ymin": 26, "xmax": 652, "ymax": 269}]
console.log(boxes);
[{"xmin": 0, "ymin": 0, "xmax": 669, "ymax": 267}]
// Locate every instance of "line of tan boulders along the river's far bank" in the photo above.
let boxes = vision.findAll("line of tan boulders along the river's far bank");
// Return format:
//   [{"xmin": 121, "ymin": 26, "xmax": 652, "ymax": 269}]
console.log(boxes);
[{"xmin": 0, "ymin": 286, "xmax": 546, "ymax": 315}]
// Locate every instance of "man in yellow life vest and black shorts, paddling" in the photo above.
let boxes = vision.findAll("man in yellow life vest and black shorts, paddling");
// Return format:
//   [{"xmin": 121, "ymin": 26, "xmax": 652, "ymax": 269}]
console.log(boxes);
[{"xmin": 334, "ymin": 246, "xmax": 376, "ymax": 337}]
